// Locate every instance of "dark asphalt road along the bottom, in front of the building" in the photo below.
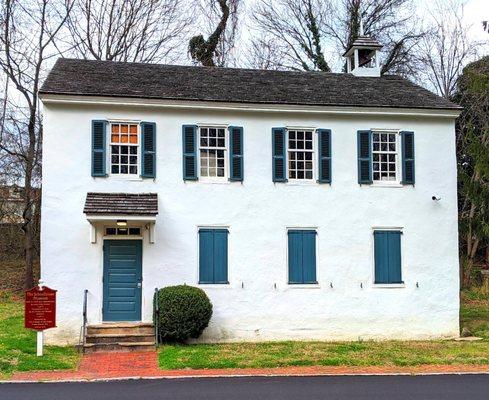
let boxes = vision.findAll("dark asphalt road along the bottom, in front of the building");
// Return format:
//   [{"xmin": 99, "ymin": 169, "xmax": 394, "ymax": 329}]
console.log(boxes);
[{"xmin": 0, "ymin": 375, "xmax": 489, "ymax": 400}]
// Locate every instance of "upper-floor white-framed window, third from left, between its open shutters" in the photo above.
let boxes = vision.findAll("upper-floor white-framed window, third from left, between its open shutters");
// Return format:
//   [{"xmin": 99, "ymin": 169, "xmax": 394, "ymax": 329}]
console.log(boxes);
[{"xmin": 287, "ymin": 129, "xmax": 314, "ymax": 180}]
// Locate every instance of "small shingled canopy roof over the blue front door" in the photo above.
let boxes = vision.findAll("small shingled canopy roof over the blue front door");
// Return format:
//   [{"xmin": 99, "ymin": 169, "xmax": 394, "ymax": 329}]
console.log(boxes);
[{"xmin": 83, "ymin": 192, "xmax": 158, "ymax": 216}]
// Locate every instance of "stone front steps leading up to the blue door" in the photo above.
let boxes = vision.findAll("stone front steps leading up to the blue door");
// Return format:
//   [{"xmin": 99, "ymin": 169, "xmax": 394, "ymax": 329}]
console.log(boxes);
[{"xmin": 84, "ymin": 322, "xmax": 155, "ymax": 353}]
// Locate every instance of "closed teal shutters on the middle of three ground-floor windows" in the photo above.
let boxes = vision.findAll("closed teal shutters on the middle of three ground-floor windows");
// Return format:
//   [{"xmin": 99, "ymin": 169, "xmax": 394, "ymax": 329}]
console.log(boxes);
[{"xmin": 287, "ymin": 230, "xmax": 317, "ymax": 284}]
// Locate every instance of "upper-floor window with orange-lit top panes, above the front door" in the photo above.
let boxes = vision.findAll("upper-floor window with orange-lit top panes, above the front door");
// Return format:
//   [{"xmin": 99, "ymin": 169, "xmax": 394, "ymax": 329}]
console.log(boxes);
[{"xmin": 110, "ymin": 122, "xmax": 140, "ymax": 175}]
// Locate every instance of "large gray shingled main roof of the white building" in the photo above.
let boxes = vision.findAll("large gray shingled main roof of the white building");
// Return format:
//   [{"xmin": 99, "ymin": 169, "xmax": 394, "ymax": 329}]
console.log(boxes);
[{"xmin": 40, "ymin": 59, "xmax": 458, "ymax": 109}]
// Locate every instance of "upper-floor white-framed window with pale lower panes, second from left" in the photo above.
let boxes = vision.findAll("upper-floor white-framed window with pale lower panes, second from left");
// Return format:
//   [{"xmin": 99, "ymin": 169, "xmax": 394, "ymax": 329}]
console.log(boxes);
[{"xmin": 199, "ymin": 126, "xmax": 227, "ymax": 178}]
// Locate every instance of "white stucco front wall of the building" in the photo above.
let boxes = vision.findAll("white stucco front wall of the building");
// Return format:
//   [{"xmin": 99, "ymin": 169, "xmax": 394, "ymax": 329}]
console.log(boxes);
[{"xmin": 41, "ymin": 100, "xmax": 459, "ymax": 343}]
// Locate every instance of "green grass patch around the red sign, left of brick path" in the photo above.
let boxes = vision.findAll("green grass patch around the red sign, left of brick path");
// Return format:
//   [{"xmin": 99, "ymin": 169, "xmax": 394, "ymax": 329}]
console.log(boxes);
[{"xmin": 0, "ymin": 292, "xmax": 78, "ymax": 379}]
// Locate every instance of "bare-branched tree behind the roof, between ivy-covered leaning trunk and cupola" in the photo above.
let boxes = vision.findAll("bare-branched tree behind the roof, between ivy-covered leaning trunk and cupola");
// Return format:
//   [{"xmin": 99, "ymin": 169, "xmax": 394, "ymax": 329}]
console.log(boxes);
[{"xmin": 252, "ymin": 0, "xmax": 330, "ymax": 71}]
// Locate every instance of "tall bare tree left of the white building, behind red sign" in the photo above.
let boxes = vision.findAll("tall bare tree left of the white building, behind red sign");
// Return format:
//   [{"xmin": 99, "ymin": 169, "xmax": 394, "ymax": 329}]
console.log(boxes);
[{"xmin": 0, "ymin": 0, "xmax": 72, "ymax": 288}]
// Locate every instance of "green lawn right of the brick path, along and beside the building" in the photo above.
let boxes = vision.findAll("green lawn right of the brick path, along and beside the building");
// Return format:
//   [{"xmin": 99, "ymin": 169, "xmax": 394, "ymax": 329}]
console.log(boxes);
[{"xmin": 159, "ymin": 291, "xmax": 489, "ymax": 369}]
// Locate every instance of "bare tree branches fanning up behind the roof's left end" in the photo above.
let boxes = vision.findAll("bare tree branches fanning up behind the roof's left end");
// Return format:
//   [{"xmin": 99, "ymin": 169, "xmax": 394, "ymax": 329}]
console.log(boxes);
[{"xmin": 67, "ymin": 0, "xmax": 192, "ymax": 62}]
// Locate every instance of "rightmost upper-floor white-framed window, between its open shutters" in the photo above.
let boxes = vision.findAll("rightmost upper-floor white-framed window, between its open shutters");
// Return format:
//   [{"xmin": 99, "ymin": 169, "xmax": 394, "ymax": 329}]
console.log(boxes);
[{"xmin": 372, "ymin": 131, "xmax": 399, "ymax": 182}]
